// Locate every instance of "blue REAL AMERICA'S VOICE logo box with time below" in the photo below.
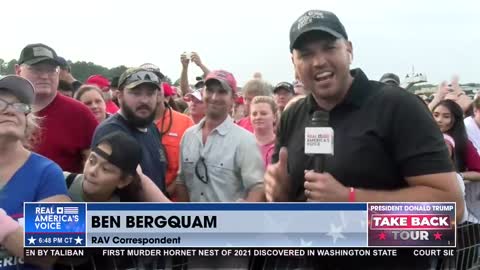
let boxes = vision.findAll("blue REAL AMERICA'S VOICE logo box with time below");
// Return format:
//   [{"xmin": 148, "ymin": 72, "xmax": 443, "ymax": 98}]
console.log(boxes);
[{"xmin": 24, "ymin": 203, "xmax": 86, "ymax": 247}]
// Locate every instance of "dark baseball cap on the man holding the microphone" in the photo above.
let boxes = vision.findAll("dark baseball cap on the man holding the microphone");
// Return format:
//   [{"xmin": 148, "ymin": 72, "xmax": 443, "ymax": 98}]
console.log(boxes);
[{"xmin": 290, "ymin": 10, "xmax": 348, "ymax": 51}]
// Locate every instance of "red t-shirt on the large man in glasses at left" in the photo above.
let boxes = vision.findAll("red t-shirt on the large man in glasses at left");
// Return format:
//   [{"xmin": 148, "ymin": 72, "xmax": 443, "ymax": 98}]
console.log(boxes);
[{"xmin": 34, "ymin": 94, "xmax": 98, "ymax": 173}]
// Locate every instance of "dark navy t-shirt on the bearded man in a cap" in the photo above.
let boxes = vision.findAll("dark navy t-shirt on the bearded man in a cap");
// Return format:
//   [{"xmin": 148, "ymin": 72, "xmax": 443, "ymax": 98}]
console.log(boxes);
[{"xmin": 92, "ymin": 113, "xmax": 167, "ymax": 193}]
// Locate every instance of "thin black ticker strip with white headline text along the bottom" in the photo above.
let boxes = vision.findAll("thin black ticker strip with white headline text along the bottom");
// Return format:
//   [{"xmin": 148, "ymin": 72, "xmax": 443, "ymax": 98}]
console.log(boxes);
[{"xmin": 24, "ymin": 248, "xmax": 456, "ymax": 257}]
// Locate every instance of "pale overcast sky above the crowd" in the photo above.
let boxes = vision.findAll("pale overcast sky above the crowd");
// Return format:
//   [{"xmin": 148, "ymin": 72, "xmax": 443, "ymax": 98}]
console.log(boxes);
[{"xmin": 0, "ymin": 0, "xmax": 480, "ymax": 85}]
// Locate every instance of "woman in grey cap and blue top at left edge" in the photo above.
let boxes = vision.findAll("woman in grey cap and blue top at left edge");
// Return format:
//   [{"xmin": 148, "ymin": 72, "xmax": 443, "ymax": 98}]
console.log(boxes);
[{"xmin": 0, "ymin": 75, "xmax": 70, "ymax": 269}]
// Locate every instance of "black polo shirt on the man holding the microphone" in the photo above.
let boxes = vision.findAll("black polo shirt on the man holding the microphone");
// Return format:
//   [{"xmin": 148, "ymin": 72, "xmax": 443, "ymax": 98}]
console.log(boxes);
[{"xmin": 272, "ymin": 69, "xmax": 453, "ymax": 201}]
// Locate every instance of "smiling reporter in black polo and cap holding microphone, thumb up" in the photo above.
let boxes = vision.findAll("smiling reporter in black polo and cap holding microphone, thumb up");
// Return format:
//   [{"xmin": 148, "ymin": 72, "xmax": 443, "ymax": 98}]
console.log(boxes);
[{"xmin": 265, "ymin": 10, "xmax": 464, "ymax": 269}]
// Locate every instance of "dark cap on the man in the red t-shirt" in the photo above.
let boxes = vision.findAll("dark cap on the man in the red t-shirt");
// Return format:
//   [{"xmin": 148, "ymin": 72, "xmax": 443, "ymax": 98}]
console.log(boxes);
[{"xmin": 18, "ymin": 43, "xmax": 61, "ymax": 66}]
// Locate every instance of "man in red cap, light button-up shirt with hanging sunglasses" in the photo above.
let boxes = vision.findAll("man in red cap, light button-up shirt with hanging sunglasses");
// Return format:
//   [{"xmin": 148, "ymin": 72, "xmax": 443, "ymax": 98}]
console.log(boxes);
[{"xmin": 177, "ymin": 70, "xmax": 265, "ymax": 269}]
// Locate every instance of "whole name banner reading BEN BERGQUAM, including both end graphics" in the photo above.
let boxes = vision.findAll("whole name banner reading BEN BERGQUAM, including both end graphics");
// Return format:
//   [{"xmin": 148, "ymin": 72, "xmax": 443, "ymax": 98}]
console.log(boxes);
[{"xmin": 24, "ymin": 203, "xmax": 456, "ymax": 248}]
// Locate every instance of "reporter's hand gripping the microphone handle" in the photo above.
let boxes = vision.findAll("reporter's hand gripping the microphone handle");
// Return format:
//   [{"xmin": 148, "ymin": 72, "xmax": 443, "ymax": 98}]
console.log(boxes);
[{"xmin": 304, "ymin": 171, "xmax": 350, "ymax": 202}]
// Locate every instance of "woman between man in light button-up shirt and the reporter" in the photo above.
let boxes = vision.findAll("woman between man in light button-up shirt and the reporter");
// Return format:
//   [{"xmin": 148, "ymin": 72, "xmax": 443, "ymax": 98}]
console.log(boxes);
[{"xmin": 250, "ymin": 96, "xmax": 278, "ymax": 168}]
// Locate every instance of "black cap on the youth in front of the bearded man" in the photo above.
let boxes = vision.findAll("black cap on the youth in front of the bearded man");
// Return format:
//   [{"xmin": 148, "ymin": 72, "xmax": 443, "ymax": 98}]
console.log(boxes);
[{"xmin": 93, "ymin": 131, "xmax": 142, "ymax": 175}]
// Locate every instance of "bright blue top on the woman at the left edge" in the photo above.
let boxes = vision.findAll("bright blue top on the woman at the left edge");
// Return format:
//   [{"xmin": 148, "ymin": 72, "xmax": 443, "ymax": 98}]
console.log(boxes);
[{"xmin": 0, "ymin": 153, "xmax": 68, "ymax": 270}]
